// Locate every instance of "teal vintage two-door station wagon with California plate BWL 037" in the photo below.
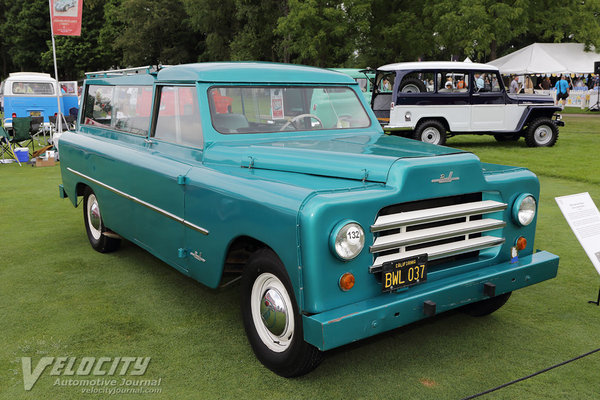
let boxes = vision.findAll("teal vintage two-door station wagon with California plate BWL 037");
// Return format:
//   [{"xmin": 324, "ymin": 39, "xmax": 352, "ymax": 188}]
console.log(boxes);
[{"xmin": 59, "ymin": 63, "xmax": 558, "ymax": 377}]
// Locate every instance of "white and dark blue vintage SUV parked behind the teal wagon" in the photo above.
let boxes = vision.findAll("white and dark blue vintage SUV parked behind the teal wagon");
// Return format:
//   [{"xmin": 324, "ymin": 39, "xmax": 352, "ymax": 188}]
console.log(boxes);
[{"xmin": 371, "ymin": 61, "xmax": 564, "ymax": 147}]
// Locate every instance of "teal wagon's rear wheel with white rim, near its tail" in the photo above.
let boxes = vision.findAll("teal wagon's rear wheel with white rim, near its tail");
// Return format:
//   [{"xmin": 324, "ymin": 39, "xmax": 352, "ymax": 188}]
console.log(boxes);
[{"xmin": 83, "ymin": 187, "xmax": 121, "ymax": 253}]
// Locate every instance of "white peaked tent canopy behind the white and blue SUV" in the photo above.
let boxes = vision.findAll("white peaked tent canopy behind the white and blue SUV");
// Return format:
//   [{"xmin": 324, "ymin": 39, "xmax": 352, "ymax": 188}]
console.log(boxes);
[{"xmin": 488, "ymin": 43, "xmax": 600, "ymax": 75}]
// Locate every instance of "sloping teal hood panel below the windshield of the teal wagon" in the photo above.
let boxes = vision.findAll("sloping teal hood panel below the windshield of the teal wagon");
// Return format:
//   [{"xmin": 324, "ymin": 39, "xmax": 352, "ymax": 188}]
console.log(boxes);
[{"xmin": 203, "ymin": 134, "xmax": 468, "ymax": 183}]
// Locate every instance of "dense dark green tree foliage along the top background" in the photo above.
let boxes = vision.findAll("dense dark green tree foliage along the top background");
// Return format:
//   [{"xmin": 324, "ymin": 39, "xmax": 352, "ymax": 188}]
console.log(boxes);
[{"xmin": 0, "ymin": 0, "xmax": 600, "ymax": 79}]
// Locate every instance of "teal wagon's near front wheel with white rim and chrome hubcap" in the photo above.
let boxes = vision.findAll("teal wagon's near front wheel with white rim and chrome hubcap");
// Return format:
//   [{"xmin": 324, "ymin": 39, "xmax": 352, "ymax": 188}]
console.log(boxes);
[{"xmin": 242, "ymin": 249, "xmax": 323, "ymax": 378}]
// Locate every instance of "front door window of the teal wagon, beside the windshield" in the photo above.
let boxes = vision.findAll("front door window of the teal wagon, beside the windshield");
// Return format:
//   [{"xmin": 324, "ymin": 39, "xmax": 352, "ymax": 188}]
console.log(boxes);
[{"xmin": 154, "ymin": 86, "xmax": 202, "ymax": 148}]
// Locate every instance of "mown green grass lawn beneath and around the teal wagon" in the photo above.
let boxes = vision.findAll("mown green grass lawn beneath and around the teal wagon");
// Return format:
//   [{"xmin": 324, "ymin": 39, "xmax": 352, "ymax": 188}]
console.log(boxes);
[{"xmin": 0, "ymin": 115, "xmax": 600, "ymax": 399}]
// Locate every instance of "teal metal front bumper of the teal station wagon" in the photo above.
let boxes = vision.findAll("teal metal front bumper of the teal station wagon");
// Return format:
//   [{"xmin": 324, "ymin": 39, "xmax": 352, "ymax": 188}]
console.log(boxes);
[{"xmin": 303, "ymin": 251, "xmax": 559, "ymax": 350}]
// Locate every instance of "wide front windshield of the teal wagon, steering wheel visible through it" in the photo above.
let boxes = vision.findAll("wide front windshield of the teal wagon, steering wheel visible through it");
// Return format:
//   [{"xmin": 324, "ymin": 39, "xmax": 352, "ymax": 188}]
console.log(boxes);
[{"xmin": 209, "ymin": 86, "xmax": 371, "ymax": 134}]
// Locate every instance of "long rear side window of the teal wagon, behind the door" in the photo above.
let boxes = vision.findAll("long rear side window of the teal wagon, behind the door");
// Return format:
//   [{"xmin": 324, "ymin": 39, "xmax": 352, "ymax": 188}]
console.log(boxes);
[{"xmin": 82, "ymin": 85, "xmax": 152, "ymax": 136}]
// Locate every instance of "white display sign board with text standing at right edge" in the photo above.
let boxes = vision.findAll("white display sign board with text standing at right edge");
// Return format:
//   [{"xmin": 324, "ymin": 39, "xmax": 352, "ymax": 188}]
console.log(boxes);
[{"xmin": 556, "ymin": 192, "xmax": 600, "ymax": 274}]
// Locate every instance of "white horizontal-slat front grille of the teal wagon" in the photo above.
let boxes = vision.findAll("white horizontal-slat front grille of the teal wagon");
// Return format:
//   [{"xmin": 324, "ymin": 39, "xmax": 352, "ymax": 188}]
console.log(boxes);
[{"xmin": 369, "ymin": 193, "xmax": 507, "ymax": 273}]
